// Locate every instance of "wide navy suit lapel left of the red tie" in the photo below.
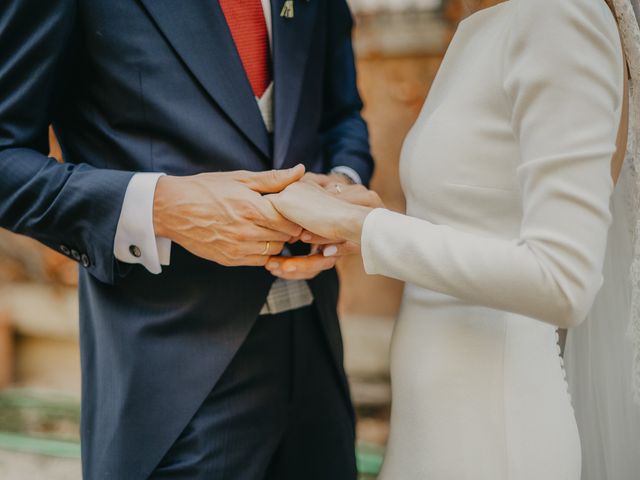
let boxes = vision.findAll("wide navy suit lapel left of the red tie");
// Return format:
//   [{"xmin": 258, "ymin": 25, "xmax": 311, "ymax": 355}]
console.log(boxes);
[{"xmin": 140, "ymin": 0, "xmax": 277, "ymax": 158}]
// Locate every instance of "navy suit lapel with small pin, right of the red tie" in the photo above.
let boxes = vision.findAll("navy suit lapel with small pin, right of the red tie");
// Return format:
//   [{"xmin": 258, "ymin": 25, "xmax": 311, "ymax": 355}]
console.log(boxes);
[{"xmin": 271, "ymin": 0, "xmax": 322, "ymax": 168}]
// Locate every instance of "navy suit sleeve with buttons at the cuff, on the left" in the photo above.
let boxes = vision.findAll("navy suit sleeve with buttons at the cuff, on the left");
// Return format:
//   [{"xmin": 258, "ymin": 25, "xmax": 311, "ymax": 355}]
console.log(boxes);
[{"xmin": 0, "ymin": 0, "xmax": 133, "ymax": 283}]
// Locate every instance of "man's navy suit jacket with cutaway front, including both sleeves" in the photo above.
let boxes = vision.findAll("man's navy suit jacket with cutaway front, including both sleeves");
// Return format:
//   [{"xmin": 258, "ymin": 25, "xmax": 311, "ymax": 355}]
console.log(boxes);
[{"xmin": 0, "ymin": 0, "xmax": 372, "ymax": 479}]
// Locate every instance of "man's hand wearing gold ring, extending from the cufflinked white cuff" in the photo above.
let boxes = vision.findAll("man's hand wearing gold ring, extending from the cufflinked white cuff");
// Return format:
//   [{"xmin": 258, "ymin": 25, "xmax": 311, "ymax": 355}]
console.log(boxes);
[{"xmin": 153, "ymin": 165, "xmax": 304, "ymax": 266}]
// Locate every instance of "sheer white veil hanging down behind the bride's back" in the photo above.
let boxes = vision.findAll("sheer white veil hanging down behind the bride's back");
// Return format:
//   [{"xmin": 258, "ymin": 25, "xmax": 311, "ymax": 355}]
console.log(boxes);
[{"xmin": 564, "ymin": 0, "xmax": 640, "ymax": 480}]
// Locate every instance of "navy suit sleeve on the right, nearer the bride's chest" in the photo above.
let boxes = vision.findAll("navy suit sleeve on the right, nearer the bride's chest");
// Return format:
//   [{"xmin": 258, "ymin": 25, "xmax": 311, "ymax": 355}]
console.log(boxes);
[{"xmin": 321, "ymin": 0, "xmax": 373, "ymax": 185}]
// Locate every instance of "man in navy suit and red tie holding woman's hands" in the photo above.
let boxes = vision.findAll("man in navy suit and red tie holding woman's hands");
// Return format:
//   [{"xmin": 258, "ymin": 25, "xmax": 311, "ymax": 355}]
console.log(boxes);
[{"xmin": 0, "ymin": 0, "xmax": 372, "ymax": 480}]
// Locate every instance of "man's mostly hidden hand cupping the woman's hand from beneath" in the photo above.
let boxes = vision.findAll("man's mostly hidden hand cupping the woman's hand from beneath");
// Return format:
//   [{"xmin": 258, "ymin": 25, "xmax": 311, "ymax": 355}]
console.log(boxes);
[{"xmin": 266, "ymin": 173, "xmax": 381, "ymax": 280}]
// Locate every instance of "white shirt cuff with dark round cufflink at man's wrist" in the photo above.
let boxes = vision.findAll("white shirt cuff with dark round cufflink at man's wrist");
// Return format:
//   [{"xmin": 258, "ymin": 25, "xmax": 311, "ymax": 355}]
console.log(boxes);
[{"xmin": 113, "ymin": 173, "xmax": 171, "ymax": 274}]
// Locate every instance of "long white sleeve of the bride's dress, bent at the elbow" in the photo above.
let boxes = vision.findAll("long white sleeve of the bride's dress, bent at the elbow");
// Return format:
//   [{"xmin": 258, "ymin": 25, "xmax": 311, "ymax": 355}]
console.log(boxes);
[{"xmin": 362, "ymin": 0, "xmax": 623, "ymax": 326}]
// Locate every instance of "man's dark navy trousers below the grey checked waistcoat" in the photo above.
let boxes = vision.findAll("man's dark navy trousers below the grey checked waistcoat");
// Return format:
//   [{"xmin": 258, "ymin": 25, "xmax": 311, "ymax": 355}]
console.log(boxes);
[{"xmin": 151, "ymin": 307, "xmax": 357, "ymax": 480}]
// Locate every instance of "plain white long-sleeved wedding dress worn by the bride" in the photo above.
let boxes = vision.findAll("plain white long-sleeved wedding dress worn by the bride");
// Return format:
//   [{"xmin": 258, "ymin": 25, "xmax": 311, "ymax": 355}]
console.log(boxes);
[{"xmin": 362, "ymin": 0, "xmax": 623, "ymax": 480}]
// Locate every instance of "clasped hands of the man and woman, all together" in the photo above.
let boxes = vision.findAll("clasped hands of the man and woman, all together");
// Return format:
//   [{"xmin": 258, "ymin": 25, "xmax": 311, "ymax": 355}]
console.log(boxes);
[{"xmin": 153, "ymin": 165, "xmax": 382, "ymax": 280}]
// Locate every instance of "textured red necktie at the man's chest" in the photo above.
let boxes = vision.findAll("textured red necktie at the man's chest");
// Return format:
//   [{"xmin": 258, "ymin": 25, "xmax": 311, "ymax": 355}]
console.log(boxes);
[{"xmin": 220, "ymin": 0, "xmax": 271, "ymax": 98}]
